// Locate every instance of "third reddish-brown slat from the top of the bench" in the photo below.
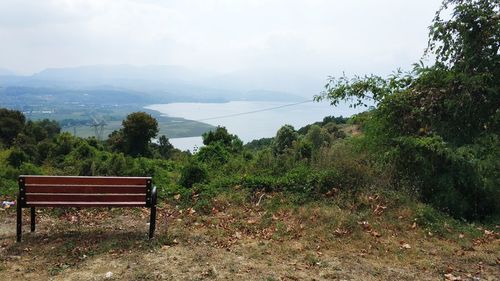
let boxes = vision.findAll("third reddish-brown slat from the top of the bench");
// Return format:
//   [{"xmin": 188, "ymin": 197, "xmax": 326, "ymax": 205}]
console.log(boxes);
[{"xmin": 26, "ymin": 194, "xmax": 146, "ymax": 203}]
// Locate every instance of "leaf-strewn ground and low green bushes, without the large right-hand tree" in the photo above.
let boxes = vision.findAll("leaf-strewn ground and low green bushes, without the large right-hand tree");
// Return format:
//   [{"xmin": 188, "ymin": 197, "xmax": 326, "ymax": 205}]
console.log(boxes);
[{"xmin": 0, "ymin": 109, "xmax": 500, "ymax": 280}]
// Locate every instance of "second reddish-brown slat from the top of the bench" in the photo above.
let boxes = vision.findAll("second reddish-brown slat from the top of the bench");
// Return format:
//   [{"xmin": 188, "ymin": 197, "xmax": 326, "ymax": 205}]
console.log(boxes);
[{"xmin": 25, "ymin": 184, "xmax": 146, "ymax": 194}]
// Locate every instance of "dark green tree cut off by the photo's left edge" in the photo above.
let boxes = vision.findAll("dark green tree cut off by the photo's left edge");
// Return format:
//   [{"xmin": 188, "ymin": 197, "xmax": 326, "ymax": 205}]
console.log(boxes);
[{"xmin": 0, "ymin": 108, "xmax": 26, "ymax": 146}]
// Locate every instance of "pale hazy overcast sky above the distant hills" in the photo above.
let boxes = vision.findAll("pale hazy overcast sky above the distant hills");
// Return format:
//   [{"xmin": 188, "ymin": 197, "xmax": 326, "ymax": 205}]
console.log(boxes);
[{"xmin": 0, "ymin": 0, "xmax": 440, "ymax": 79}]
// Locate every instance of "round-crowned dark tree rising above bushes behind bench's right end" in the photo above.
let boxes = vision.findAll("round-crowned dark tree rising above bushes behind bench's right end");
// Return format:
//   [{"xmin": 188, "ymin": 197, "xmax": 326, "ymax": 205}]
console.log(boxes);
[{"xmin": 122, "ymin": 112, "xmax": 158, "ymax": 156}]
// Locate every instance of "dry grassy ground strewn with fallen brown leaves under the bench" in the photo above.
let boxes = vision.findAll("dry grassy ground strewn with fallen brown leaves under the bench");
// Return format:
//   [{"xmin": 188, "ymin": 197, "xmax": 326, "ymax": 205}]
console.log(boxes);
[{"xmin": 0, "ymin": 188, "xmax": 500, "ymax": 280}]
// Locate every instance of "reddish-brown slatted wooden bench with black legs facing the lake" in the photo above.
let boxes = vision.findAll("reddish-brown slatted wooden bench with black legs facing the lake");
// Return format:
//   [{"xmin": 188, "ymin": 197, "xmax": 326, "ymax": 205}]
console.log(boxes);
[{"xmin": 17, "ymin": 175, "xmax": 156, "ymax": 242}]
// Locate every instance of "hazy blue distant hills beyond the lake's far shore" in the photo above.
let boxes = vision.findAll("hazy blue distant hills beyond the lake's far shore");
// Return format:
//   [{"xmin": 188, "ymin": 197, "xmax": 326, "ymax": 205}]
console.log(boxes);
[{"xmin": 0, "ymin": 65, "xmax": 304, "ymax": 104}]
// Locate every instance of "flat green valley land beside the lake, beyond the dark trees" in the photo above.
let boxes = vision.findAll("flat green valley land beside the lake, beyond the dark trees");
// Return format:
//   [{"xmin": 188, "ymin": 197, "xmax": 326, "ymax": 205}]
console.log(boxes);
[{"xmin": 0, "ymin": 97, "xmax": 213, "ymax": 138}]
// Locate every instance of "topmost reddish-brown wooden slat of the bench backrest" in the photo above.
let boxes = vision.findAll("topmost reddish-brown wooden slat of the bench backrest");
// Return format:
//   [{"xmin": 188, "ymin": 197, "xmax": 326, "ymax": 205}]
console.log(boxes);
[{"xmin": 20, "ymin": 176, "xmax": 151, "ymax": 185}]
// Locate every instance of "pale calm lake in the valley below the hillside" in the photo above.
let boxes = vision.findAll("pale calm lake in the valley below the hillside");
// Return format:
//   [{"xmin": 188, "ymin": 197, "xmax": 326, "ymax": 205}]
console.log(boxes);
[{"xmin": 146, "ymin": 101, "xmax": 365, "ymax": 151}]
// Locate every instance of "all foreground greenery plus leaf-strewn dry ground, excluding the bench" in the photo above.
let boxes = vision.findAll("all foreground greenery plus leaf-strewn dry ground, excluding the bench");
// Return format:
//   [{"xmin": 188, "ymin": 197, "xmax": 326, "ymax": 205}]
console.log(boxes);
[{"xmin": 0, "ymin": 0, "xmax": 500, "ymax": 280}]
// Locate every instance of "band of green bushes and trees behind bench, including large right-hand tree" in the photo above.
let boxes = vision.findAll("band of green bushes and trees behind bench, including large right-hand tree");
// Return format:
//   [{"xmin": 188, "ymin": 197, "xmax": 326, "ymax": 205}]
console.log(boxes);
[{"xmin": 0, "ymin": 0, "xmax": 500, "ymax": 228}]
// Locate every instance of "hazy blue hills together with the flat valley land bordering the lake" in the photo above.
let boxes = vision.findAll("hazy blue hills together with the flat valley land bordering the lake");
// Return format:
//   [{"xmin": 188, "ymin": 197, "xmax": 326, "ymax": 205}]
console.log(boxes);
[{"xmin": 0, "ymin": 65, "xmax": 304, "ymax": 138}]
